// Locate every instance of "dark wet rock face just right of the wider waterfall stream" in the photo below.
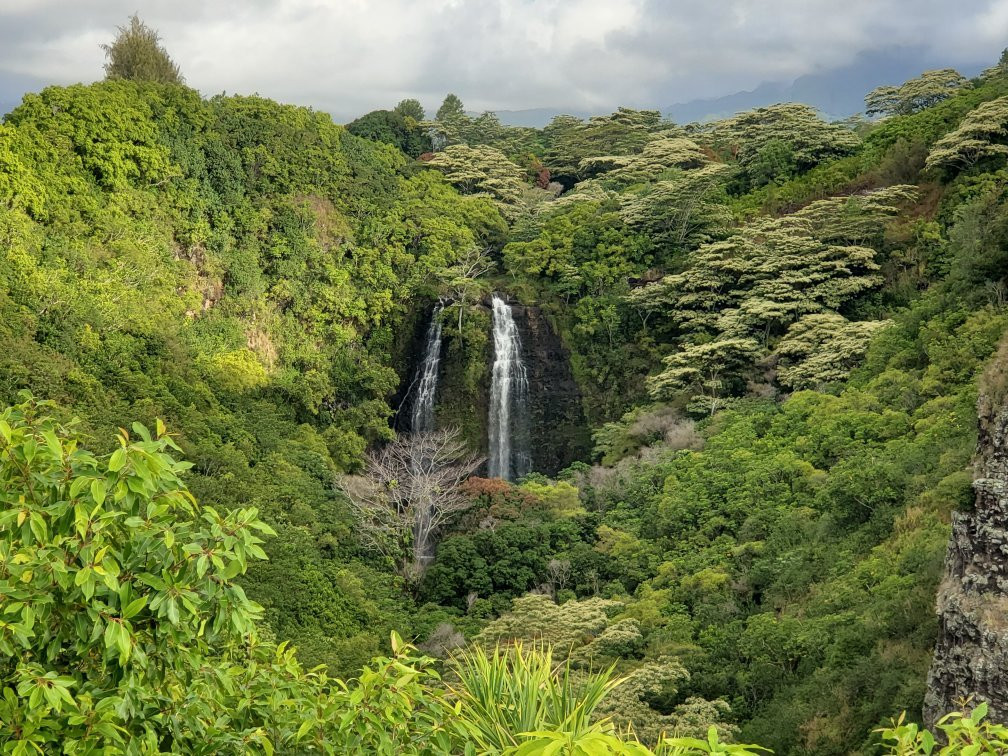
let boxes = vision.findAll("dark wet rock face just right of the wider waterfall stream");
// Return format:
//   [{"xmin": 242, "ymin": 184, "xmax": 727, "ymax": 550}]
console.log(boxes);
[{"xmin": 511, "ymin": 303, "xmax": 591, "ymax": 475}]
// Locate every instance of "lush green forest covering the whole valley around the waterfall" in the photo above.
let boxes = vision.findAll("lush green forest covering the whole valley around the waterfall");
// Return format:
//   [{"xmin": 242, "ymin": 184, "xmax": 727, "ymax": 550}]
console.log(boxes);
[{"xmin": 0, "ymin": 17, "xmax": 1008, "ymax": 755}]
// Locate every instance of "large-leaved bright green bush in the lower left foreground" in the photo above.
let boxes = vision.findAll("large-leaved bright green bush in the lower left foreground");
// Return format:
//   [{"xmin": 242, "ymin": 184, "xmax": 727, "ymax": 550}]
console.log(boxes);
[{"xmin": 0, "ymin": 397, "xmax": 312, "ymax": 753}]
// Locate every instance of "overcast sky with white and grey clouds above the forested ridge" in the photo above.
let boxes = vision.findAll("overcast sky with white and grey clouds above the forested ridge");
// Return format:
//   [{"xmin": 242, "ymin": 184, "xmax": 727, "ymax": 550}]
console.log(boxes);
[{"xmin": 0, "ymin": 0, "xmax": 1008, "ymax": 120}]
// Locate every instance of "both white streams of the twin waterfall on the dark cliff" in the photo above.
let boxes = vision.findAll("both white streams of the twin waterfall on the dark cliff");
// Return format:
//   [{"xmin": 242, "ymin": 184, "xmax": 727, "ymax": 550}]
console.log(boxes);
[{"xmin": 410, "ymin": 294, "xmax": 532, "ymax": 480}]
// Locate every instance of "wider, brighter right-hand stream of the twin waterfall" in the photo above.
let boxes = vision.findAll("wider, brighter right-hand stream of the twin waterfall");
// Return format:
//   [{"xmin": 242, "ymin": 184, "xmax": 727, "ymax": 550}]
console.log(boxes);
[{"xmin": 487, "ymin": 294, "xmax": 531, "ymax": 480}]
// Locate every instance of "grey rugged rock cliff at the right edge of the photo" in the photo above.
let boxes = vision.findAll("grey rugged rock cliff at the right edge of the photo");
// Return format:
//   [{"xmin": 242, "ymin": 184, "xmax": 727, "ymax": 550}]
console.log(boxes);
[{"xmin": 923, "ymin": 397, "xmax": 1008, "ymax": 726}]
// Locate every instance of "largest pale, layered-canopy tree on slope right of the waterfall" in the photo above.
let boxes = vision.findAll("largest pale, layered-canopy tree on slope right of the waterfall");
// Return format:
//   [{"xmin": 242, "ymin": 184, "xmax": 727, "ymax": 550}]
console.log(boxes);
[{"xmin": 629, "ymin": 185, "xmax": 916, "ymax": 341}]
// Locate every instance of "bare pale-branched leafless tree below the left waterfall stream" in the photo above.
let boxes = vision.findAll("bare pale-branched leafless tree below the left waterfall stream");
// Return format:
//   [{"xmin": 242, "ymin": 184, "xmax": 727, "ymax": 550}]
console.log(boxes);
[{"xmin": 337, "ymin": 428, "xmax": 484, "ymax": 585}]
